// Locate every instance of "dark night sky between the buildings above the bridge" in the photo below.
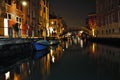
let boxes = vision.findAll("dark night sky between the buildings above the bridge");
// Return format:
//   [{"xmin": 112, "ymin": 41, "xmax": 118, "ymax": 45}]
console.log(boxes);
[{"xmin": 50, "ymin": 0, "xmax": 96, "ymax": 27}]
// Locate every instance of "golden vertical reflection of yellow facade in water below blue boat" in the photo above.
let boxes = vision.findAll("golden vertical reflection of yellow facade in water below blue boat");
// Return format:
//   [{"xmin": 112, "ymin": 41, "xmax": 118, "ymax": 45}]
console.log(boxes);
[{"xmin": 31, "ymin": 54, "xmax": 50, "ymax": 80}]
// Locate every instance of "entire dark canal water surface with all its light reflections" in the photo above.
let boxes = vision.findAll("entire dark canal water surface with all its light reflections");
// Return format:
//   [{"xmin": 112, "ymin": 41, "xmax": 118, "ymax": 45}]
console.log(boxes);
[{"xmin": 0, "ymin": 38, "xmax": 120, "ymax": 80}]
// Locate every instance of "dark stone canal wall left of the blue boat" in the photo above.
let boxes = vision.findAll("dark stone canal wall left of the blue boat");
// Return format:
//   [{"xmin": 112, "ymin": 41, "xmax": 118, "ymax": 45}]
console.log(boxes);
[{"xmin": 0, "ymin": 39, "xmax": 33, "ymax": 58}]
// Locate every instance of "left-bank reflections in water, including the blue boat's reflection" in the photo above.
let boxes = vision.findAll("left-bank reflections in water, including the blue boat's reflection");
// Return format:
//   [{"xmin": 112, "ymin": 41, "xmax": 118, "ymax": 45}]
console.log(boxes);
[{"xmin": 0, "ymin": 42, "xmax": 63, "ymax": 80}]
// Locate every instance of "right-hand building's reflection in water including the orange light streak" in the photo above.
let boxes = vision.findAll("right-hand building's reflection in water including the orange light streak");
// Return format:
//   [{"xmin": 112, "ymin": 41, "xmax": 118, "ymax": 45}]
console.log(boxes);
[{"xmin": 89, "ymin": 43, "xmax": 120, "ymax": 62}]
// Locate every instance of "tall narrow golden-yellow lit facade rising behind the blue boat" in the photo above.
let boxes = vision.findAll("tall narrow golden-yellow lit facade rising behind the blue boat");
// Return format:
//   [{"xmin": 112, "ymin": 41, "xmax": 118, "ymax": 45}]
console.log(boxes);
[{"xmin": 38, "ymin": 0, "xmax": 49, "ymax": 37}]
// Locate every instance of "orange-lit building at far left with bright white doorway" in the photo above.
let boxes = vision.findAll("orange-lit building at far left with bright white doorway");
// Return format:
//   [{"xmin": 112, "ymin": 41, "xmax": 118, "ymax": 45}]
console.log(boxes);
[{"xmin": 0, "ymin": 0, "xmax": 22, "ymax": 37}]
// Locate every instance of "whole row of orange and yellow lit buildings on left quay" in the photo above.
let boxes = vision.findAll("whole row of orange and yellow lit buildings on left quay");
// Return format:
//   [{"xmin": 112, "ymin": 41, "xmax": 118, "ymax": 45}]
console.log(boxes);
[{"xmin": 0, "ymin": 0, "xmax": 49, "ymax": 38}]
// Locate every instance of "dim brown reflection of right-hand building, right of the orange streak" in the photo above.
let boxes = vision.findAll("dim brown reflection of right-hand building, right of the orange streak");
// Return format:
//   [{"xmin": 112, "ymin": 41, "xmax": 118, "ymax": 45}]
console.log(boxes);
[{"xmin": 95, "ymin": 45, "xmax": 120, "ymax": 63}]
